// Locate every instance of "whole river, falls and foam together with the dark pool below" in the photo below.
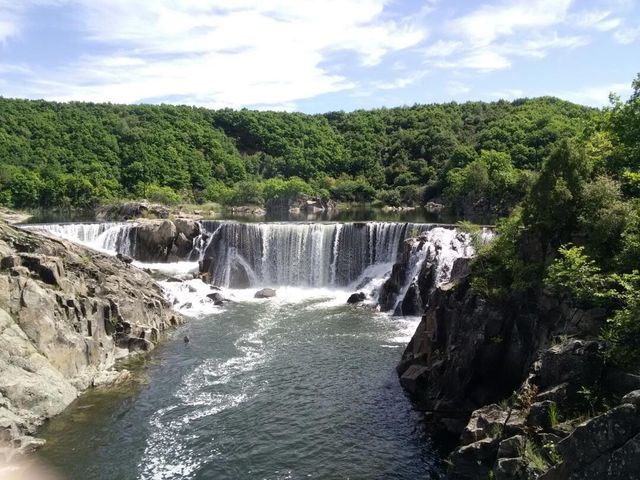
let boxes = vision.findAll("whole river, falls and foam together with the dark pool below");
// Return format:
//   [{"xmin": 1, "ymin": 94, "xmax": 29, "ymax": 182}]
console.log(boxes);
[{"xmin": 23, "ymin": 218, "xmax": 470, "ymax": 480}]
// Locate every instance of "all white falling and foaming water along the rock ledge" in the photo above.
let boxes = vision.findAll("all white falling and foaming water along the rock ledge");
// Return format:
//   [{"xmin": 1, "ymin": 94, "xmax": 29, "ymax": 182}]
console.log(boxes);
[{"xmin": 26, "ymin": 221, "xmax": 491, "ymax": 316}]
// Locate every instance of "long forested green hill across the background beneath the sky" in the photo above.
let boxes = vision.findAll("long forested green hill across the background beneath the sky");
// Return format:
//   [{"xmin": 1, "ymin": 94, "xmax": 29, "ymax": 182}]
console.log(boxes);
[{"xmin": 0, "ymin": 97, "xmax": 600, "ymax": 212}]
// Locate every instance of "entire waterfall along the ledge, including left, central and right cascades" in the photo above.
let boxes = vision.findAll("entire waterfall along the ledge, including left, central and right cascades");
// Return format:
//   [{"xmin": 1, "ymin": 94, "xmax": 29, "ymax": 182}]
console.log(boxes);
[{"xmin": 25, "ymin": 220, "xmax": 493, "ymax": 314}]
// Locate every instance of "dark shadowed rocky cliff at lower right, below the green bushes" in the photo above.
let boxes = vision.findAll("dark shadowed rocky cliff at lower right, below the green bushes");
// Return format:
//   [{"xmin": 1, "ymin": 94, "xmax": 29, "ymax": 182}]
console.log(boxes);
[{"xmin": 398, "ymin": 262, "xmax": 640, "ymax": 479}]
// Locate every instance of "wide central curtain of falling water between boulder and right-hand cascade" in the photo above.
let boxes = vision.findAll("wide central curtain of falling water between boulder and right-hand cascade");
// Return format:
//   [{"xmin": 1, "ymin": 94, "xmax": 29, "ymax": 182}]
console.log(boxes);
[{"xmin": 200, "ymin": 222, "xmax": 438, "ymax": 287}]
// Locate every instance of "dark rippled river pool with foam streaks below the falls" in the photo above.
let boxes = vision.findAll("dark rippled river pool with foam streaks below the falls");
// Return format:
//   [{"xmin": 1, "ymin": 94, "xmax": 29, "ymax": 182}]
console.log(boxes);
[{"xmin": 39, "ymin": 289, "xmax": 437, "ymax": 480}]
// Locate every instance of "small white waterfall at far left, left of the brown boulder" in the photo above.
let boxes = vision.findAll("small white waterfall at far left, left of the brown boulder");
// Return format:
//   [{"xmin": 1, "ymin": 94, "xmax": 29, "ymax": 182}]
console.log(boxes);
[{"xmin": 24, "ymin": 223, "xmax": 136, "ymax": 255}]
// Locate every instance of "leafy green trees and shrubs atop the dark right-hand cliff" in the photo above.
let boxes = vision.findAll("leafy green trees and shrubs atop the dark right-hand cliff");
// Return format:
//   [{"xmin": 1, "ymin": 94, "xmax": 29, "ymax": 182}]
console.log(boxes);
[{"xmin": 473, "ymin": 76, "xmax": 640, "ymax": 368}]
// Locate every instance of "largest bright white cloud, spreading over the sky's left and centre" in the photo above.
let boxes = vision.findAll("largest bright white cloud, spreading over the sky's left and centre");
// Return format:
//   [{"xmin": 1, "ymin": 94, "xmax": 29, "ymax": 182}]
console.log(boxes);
[{"xmin": 0, "ymin": 0, "xmax": 426, "ymax": 109}]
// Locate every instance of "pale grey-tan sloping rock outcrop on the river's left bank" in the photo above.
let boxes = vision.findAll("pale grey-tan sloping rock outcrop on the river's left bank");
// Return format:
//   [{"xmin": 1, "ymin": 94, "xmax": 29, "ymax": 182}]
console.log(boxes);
[{"xmin": 0, "ymin": 219, "xmax": 181, "ymax": 460}]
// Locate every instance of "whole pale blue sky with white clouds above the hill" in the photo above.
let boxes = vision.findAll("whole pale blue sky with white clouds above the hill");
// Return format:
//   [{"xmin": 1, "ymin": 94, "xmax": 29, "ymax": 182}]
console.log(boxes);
[{"xmin": 0, "ymin": 0, "xmax": 640, "ymax": 113}]
